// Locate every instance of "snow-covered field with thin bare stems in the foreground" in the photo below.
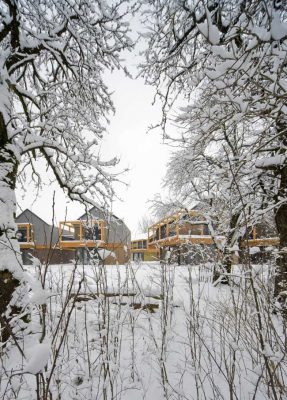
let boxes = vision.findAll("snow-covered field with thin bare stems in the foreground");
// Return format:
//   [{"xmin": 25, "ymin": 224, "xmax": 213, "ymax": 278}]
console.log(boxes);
[{"xmin": 0, "ymin": 263, "xmax": 286, "ymax": 400}]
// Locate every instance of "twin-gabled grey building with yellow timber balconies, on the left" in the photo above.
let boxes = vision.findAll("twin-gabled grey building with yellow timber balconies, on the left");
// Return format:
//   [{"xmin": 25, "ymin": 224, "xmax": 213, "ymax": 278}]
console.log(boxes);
[{"xmin": 16, "ymin": 207, "xmax": 131, "ymax": 265}]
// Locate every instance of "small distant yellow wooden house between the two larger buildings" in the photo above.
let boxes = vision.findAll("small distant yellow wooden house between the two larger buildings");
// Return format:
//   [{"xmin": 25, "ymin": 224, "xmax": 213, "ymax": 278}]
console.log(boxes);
[{"xmin": 131, "ymin": 234, "xmax": 160, "ymax": 261}]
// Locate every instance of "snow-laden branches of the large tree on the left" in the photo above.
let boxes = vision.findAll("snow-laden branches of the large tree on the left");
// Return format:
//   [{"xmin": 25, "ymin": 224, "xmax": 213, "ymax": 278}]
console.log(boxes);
[{"xmin": 0, "ymin": 0, "xmax": 132, "ymax": 334}]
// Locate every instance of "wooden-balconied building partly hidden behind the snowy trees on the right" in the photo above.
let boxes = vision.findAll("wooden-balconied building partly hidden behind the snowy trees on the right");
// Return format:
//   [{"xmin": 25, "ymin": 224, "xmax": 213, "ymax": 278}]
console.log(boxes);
[{"xmin": 143, "ymin": 209, "xmax": 279, "ymax": 264}]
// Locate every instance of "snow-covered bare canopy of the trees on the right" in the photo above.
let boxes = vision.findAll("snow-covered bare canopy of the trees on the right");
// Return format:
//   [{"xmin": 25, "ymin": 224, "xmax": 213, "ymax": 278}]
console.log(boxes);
[{"xmin": 141, "ymin": 0, "xmax": 287, "ymax": 296}]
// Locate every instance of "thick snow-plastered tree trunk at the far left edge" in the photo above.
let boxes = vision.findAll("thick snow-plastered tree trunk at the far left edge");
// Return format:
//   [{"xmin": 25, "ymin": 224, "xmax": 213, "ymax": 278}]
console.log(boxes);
[{"xmin": 0, "ymin": 112, "xmax": 23, "ymax": 341}]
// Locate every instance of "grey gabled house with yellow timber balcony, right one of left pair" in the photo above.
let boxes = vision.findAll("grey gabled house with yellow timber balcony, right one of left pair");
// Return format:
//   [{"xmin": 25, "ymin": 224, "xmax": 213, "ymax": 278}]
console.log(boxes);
[{"xmin": 59, "ymin": 207, "xmax": 131, "ymax": 265}]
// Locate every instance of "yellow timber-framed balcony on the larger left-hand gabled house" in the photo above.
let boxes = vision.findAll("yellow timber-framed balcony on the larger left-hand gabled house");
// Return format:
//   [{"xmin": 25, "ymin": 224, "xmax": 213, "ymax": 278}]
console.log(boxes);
[{"xmin": 59, "ymin": 220, "xmax": 105, "ymax": 249}]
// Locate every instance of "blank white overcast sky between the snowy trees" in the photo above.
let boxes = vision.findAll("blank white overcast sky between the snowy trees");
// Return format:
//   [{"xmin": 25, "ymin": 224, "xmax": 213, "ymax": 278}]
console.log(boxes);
[{"xmin": 17, "ymin": 61, "xmax": 173, "ymax": 236}]
